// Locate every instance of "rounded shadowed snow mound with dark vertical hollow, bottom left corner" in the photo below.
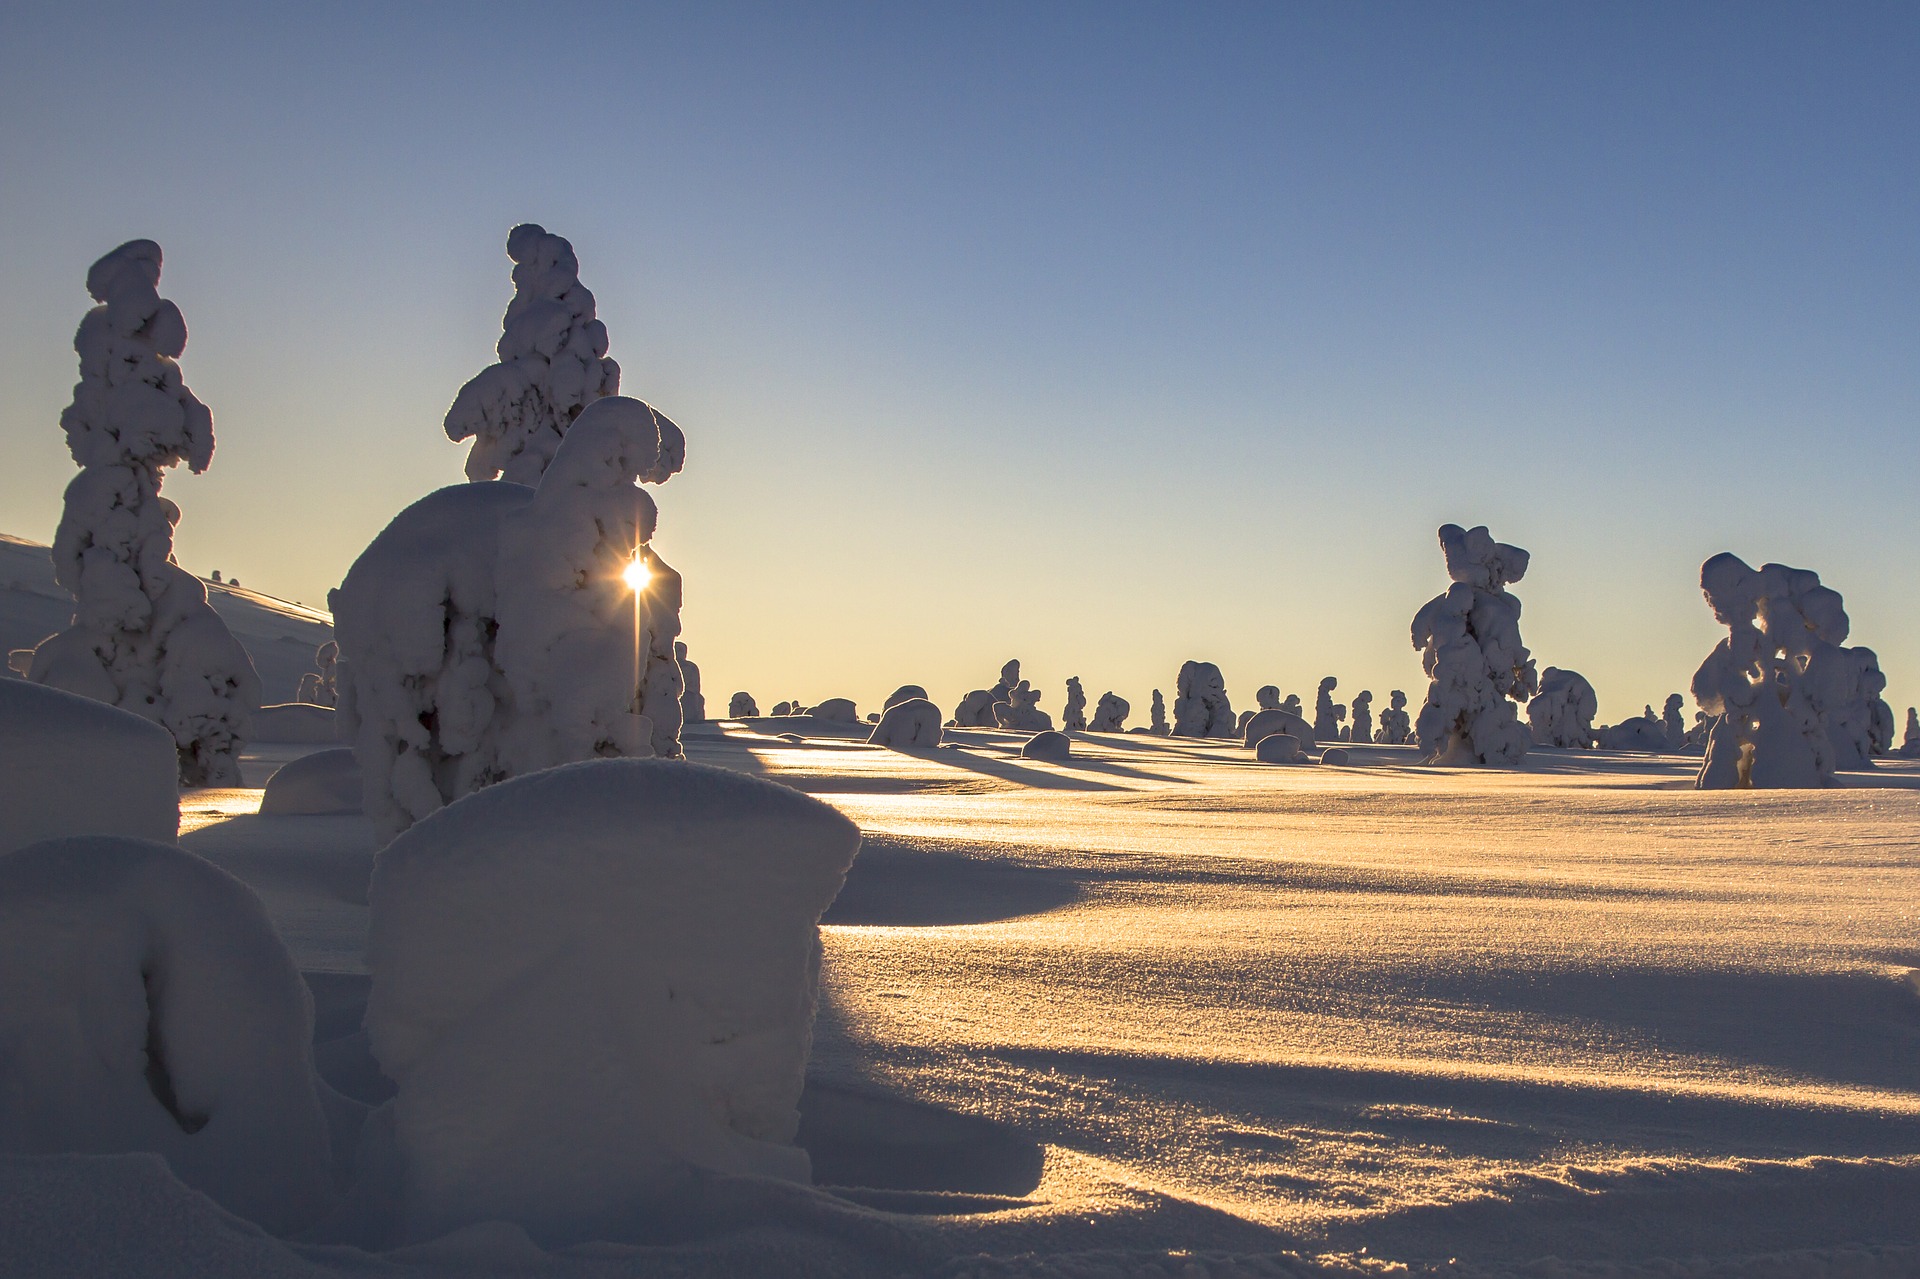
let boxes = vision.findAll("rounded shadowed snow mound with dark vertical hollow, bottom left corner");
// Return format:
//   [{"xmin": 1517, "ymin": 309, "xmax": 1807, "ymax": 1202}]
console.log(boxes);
[{"xmin": 0, "ymin": 835, "xmax": 334, "ymax": 1231}]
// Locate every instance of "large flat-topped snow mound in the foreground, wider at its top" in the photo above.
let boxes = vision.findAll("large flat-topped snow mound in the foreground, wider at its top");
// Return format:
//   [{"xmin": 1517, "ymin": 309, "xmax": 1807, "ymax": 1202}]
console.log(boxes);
[{"xmin": 367, "ymin": 760, "xmax": 860, "ymax": 1241}]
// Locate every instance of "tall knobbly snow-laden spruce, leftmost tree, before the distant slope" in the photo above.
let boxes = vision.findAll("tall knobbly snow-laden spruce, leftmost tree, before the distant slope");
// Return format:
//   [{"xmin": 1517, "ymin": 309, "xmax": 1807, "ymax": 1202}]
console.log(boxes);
[{"xmin": 27, "ymin": 240, "xmax": 259, "ymax": 785}]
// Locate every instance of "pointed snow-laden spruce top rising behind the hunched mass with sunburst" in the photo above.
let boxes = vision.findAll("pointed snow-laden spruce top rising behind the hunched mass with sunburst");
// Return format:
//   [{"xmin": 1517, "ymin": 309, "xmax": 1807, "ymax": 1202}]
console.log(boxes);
[{"xmin": 445, "ymin": 223, "xmax": 620, "ymax": 484}]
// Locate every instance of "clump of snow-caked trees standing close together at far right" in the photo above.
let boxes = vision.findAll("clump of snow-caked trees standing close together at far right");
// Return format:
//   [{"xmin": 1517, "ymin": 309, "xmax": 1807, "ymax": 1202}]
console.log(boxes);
[{"xmin": 1693, "ymin": 551, "xmax": 1858, "ymax": 789}]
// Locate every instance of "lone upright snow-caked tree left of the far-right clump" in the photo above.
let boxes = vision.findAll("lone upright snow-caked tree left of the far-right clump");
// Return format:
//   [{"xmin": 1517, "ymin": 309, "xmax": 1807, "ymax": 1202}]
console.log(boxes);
[{"xmin": 1413, "ymin": 524, "xmax": 1538, "ymax": 766}]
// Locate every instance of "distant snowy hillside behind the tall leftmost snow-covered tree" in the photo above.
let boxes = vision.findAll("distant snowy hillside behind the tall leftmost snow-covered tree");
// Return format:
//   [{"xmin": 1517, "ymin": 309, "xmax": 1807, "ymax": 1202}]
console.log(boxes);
[{"xmin": 0, "ymin": 534, "xmax": 334, "ymax": 703}]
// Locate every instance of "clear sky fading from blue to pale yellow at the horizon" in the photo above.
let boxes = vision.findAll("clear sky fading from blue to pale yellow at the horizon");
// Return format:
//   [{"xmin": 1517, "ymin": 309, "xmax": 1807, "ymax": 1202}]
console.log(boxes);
[{"xmin": 0, "ymin": 2, "xmax": 1920, "ymax": 722}]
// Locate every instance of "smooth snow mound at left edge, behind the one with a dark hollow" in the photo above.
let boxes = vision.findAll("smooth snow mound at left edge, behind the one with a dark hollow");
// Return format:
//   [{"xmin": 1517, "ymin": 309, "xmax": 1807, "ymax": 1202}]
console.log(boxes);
[{"xmin": 0, "ymin": 680, "xmax": 180, "ymax": 853}]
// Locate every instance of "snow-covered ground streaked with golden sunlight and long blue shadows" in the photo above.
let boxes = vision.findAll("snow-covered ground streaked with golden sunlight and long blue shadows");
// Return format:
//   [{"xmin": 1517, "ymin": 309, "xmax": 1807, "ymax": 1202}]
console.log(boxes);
[{"xmin": 0, "ymin": 718, "xmax": 1920, "ymax": 1275}]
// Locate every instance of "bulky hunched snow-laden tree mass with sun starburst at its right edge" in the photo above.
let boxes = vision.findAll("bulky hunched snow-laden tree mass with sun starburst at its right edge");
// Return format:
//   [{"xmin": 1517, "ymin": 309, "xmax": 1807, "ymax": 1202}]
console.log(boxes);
[{"xmin": 330, "ymin": 396, "xmax": 682, "ymax": 835}]
